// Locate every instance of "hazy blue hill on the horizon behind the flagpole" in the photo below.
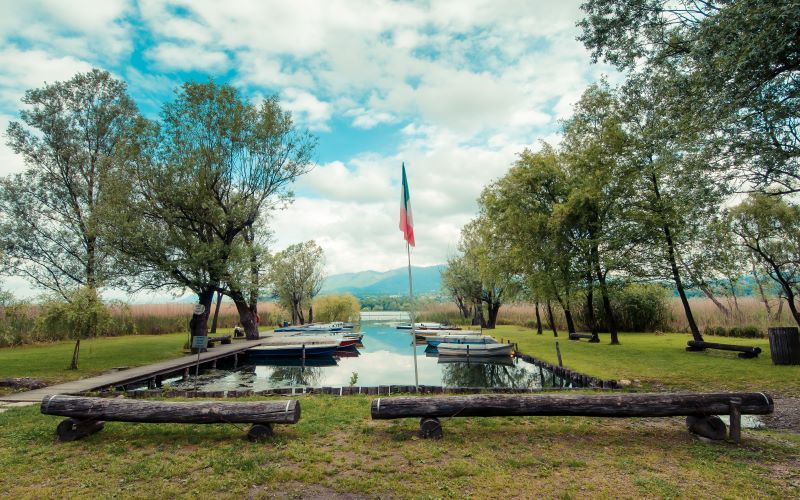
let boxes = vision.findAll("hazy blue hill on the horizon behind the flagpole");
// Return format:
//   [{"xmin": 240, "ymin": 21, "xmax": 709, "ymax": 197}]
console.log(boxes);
[{"xmin": 321, "ymin": 265, "xmax": 445, "ymax": 296}]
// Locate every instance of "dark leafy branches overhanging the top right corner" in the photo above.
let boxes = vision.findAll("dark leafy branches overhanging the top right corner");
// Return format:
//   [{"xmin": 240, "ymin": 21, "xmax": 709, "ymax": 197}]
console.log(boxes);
[{"xmin": 579, "ymin": 0, "xmax": 800, "ymax": 193}]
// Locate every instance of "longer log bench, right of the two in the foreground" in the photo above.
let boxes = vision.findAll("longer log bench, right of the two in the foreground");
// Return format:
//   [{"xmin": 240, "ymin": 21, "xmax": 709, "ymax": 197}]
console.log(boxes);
[{"xmin": 371, "ymin": 392, "xmax": 774, "ymax": 443}]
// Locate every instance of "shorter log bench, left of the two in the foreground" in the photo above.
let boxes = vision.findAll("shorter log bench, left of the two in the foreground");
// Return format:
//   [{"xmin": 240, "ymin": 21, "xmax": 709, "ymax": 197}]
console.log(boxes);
[{"xmin": 41, "ymin": 394, "xmax": 300, "ymax": 441}]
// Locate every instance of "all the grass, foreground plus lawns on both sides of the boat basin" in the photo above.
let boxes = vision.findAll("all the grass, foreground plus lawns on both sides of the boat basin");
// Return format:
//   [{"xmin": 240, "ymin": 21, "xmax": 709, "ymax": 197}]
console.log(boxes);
[{"xmin": 0, "ymin": 326, "xmax": 800, "ymax": 498}]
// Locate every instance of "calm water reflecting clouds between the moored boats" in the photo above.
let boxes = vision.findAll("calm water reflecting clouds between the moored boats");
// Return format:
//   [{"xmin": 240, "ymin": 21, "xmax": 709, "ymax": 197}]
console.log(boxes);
[{"xmin": 164, "ymin": 322, "xmax": 569, "ymax": 391}]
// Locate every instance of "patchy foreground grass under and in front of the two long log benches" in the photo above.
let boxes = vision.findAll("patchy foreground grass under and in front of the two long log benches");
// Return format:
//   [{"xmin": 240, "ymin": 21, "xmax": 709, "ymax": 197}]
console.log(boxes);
[{"xmin": 0, "ymin": 396, "xmax": 800, "ymax": 498}]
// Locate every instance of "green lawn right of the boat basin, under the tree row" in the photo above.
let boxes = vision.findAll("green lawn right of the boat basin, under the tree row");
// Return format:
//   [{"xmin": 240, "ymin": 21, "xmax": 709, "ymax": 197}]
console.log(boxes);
[{"xmin": 494, "ymin": 325, "xmax": 800, "ymax": 395}]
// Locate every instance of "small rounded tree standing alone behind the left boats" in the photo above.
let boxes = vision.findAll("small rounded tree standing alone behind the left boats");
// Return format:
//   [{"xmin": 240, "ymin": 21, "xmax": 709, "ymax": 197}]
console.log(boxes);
[{"xmin": 269, "ymin": 240, "xmax": 325, "ymax": 324}]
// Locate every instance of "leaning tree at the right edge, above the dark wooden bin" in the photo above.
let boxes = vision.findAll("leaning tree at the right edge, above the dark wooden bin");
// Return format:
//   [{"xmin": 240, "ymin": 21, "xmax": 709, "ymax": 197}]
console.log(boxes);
[{"xmin": 728, "ymin": 193, "xmax": 800, "ymax": 325}]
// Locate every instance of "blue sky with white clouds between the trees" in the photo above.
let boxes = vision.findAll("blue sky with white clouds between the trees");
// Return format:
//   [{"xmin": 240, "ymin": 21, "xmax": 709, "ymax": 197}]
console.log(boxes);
[{"xmin": 0, "ymin": 0, "xmax": 613, "ymax": 298}]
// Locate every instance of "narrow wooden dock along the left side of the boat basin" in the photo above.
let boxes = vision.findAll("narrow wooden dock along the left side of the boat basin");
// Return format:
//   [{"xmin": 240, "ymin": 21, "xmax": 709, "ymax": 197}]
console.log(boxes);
[{"xmin": 0, "ymin": 336, "xmax": 272, "ymax": 403}]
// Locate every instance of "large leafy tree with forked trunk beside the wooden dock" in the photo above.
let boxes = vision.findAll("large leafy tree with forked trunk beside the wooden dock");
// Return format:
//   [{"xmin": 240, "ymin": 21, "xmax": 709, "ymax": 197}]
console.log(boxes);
[{"xmin": 107, "ymin": 82, "xmax": 315, "ymax": 346}]
